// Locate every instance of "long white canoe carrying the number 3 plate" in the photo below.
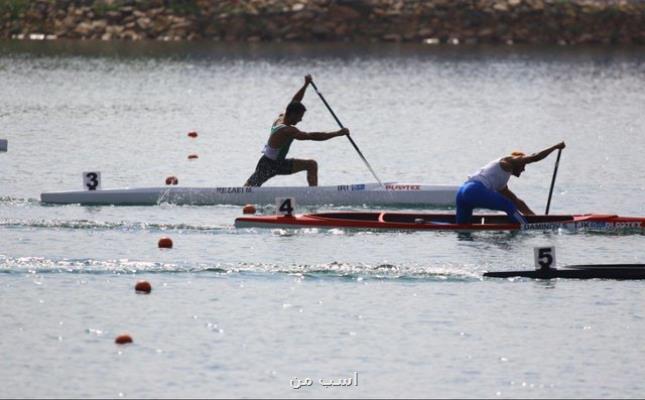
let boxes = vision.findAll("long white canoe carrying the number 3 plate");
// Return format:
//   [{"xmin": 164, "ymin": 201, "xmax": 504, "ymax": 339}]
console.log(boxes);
[{"xmin": 40, "ymin": 182, "xmax": 459, "ymax": 206}]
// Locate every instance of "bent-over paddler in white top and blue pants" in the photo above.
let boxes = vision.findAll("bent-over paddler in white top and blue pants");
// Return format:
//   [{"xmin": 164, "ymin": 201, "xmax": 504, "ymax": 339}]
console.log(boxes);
[{"xmin": 456, "ymin": 142, "xmax": 566, "ymax": 224}]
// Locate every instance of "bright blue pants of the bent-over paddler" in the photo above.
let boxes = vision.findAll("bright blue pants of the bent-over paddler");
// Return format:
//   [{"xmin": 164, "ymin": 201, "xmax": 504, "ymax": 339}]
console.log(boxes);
[{"xmin": 456, "ymin": 181, "xmax": 526, "ymax": 224}]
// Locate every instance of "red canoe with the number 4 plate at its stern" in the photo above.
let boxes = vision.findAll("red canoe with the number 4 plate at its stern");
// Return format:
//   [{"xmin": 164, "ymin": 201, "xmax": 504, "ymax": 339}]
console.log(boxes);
[{"xmin": 235, "ymin": 212, "xmax": 645, "ymax": 233}]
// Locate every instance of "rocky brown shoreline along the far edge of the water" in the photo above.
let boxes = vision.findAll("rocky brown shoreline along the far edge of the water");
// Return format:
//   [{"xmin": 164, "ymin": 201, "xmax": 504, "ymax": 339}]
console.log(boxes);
[{"xmin": 0, "ymin": 0, "xmax": 645, "ymax": 45}]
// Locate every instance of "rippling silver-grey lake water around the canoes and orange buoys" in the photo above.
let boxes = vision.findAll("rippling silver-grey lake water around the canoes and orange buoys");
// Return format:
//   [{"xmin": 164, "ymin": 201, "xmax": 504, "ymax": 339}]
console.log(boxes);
[{"xmin": 0, "ymin": 41, "xmax": 645, "ymax": 398}]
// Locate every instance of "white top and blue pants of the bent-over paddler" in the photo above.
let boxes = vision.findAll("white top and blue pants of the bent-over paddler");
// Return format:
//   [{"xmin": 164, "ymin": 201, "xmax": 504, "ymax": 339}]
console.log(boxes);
[{"xmin": 456, "ymin": 158, "xmax": 527, "ymax": 224}]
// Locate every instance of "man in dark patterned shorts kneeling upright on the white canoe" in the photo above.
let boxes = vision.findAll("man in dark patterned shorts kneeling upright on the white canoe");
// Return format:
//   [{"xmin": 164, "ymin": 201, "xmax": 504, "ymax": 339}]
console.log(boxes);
[{"xmin": 244, "ymin": 75, "xmax": 349, "ymax": 186}]
